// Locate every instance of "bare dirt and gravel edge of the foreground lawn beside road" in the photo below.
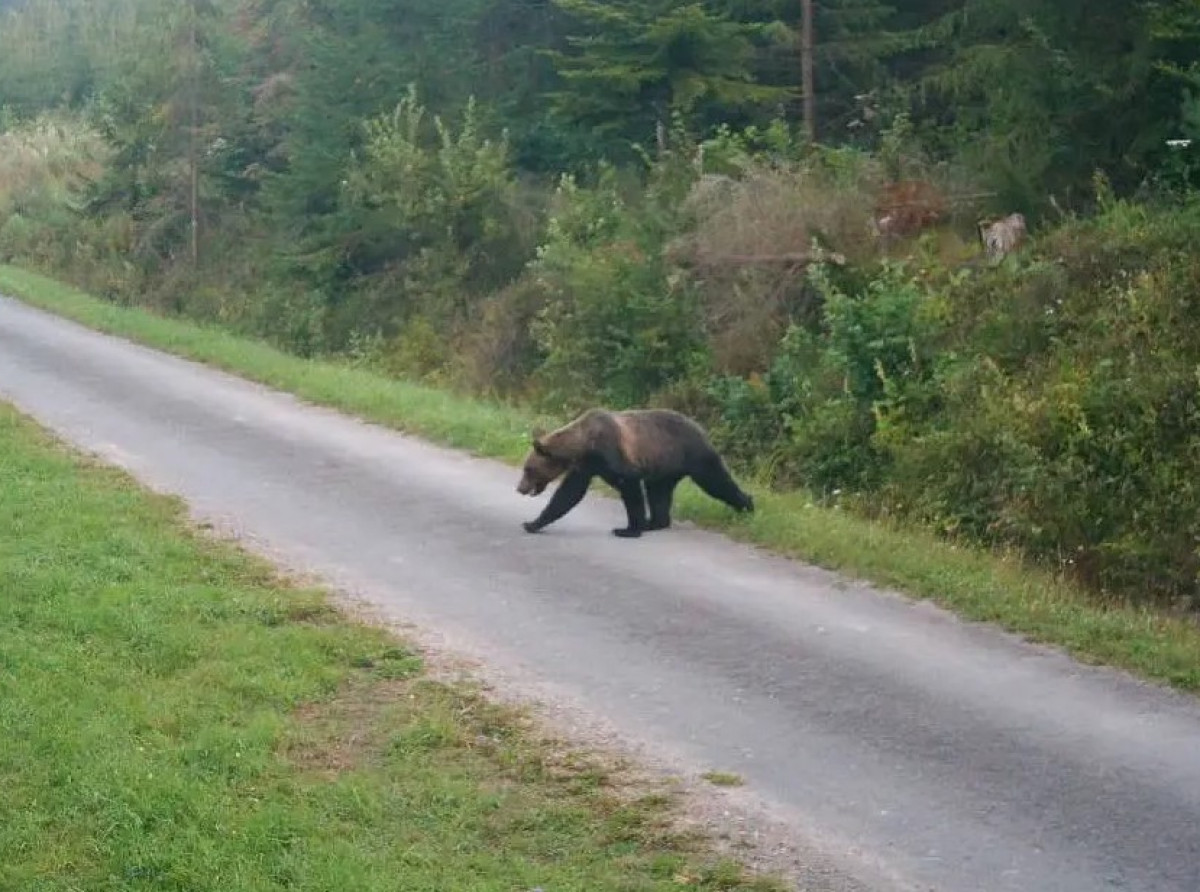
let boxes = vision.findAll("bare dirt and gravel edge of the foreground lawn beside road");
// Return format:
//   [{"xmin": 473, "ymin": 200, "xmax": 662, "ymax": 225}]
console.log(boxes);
[{"xmin": 285, "ymin": 593, "xmax": 866, "ymax": 892}]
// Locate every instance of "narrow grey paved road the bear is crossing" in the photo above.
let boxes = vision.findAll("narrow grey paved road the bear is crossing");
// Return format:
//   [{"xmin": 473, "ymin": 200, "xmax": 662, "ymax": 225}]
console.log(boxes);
[{"xmin": 7, "ymin": 299, "xmax": 1200, "ymax": 892}]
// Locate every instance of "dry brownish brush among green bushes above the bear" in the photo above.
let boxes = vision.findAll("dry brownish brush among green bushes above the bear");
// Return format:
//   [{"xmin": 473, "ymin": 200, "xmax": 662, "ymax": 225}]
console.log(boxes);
[{"xmin": 668, "ymin": 154, "xmax": 977, "ymax": 376}]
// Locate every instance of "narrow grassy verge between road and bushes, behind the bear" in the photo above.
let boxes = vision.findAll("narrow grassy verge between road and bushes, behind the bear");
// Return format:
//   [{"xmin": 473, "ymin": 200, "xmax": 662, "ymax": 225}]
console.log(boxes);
[{"xmin": 0, "ymin": 261, "xmax": 1200, "ymax": 690}]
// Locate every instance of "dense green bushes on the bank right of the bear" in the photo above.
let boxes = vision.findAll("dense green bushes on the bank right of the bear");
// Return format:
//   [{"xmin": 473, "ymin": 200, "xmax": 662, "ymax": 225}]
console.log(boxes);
[{"xmin": 707, "ymin": 196, "xmax": 1200, "ymax": 607}]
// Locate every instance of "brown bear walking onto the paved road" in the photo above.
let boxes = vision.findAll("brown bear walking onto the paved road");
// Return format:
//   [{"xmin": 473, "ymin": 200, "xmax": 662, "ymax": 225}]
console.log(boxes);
[{"xmin": 517, "ymin": 408, "xmax": 754, "ymax": 538}]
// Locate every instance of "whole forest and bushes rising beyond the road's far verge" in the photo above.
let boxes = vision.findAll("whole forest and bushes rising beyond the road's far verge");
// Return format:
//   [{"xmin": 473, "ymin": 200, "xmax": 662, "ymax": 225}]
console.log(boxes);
[{"xmin": 0, "ymin": 0, "xmax": 1200, "ymax": 610}]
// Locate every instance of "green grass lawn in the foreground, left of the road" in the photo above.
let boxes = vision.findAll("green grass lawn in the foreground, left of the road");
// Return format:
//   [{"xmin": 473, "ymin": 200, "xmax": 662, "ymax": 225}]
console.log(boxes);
[{"xmin": 0, "ymin": 405, "xmax": 778, "ymax": 892}]
